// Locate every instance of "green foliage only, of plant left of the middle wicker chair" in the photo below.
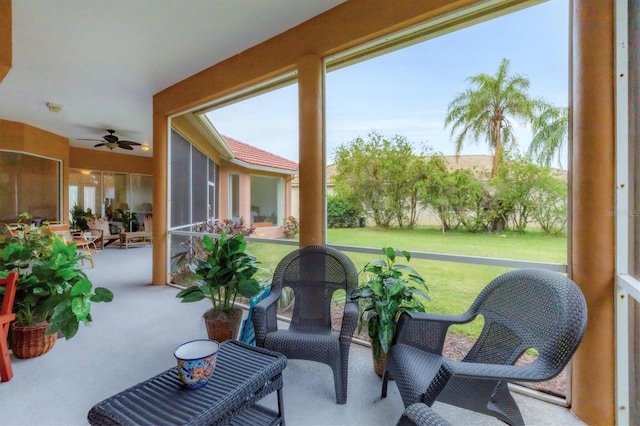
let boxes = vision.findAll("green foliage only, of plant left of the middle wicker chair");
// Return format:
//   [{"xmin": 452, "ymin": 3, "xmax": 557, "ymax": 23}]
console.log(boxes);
[{"xmin": 176, "ymin": 231, "xmax": 261, "ymax": 311}]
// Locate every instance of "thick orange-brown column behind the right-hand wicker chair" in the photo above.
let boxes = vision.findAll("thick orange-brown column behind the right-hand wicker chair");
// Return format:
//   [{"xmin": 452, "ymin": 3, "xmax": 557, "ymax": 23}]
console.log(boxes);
[{"xmin": 570, "ymin": 0, "xmax": 615, "ymax": 425}]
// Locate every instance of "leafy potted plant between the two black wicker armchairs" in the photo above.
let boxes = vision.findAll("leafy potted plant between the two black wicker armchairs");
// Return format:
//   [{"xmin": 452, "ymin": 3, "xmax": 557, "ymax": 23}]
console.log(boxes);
[{"xmin": 351, "ymin": 247, "xmax": 429, "ymax": 376}]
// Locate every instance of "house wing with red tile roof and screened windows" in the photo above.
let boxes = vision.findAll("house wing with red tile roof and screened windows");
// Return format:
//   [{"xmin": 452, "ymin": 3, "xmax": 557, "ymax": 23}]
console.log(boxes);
[{"xmin": 170, "ymin": 114, "xmax": 298, "ymax": 238}]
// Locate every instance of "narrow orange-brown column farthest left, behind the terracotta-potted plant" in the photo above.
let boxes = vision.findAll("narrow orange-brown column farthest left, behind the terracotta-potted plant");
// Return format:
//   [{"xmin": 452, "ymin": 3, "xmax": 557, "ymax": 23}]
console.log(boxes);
[{"xmin": 151, "ymin": 114, "xmax": 169, "ymax": 285}]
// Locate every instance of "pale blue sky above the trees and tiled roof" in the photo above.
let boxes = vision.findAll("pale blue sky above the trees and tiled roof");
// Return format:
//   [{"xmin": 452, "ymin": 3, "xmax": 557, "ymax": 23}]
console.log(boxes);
[{"xmin": 208, "ymin": 0, "xmax": 569, "ymax": 165}]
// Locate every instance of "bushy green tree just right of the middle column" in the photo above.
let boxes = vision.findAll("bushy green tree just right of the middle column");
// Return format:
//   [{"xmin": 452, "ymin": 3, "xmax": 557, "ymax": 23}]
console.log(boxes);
[{"xmin": 333, "ymin": 131, "xmax": 421, "ymax": 227}]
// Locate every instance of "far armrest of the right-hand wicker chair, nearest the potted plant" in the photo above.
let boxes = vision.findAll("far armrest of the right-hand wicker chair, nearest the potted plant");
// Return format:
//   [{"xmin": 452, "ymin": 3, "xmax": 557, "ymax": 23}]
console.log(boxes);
[{"xmin": 393, "ymin": 311, "xmax": 476, "ymax": 355}]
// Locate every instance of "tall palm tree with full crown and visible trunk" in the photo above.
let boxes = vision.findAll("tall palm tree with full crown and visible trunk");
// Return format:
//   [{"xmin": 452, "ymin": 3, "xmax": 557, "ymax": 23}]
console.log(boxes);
[{"xmin": 445, "ymin": 58, "xmax": 541, "ymax": 176}]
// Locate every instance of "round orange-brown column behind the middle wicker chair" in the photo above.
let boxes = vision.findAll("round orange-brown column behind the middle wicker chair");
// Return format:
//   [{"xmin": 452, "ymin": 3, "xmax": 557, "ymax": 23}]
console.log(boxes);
[{"xmin": 298, "ymin": 55, "xmax": 326, "ymax": 247}]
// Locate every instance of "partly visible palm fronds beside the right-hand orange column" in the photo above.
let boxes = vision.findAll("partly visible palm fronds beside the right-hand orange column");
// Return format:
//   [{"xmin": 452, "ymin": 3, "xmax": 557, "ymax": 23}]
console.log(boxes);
[{"xmin": 527, "ymin": 104, "xmax": 569, "ymax": 167}]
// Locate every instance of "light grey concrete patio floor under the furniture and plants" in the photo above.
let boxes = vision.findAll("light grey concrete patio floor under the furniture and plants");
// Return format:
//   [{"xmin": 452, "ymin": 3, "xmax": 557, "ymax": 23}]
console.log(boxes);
[{"xmin": 0, "ymin": 247, "xmax": 584, "ymax": 426}]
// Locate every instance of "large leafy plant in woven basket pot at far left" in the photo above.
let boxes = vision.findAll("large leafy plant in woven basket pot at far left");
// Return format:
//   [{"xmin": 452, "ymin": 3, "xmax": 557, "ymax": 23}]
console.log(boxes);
[{"xmin": 0, "ymin": 218, "xmax": 113, "ymax": 358}]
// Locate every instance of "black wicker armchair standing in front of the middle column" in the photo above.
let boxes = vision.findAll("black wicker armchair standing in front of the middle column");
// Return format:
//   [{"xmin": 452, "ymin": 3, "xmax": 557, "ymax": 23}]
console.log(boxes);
[{"xmin": 253, "ymin": 246, "xmax": 358, "ymax": 404}]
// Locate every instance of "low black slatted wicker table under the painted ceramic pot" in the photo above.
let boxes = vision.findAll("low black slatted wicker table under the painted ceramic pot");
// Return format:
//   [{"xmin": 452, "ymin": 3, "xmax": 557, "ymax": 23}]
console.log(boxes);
[{"xmin": 87, "ymin": 340, "xmax": 287, "ymax": 426}]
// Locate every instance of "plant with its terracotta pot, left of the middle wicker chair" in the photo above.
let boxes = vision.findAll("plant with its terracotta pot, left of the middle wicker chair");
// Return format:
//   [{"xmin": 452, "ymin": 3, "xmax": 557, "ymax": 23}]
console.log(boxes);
[{"xmin": 176, "ymin": 231, "xmax": 262, "ymax": 342}]
